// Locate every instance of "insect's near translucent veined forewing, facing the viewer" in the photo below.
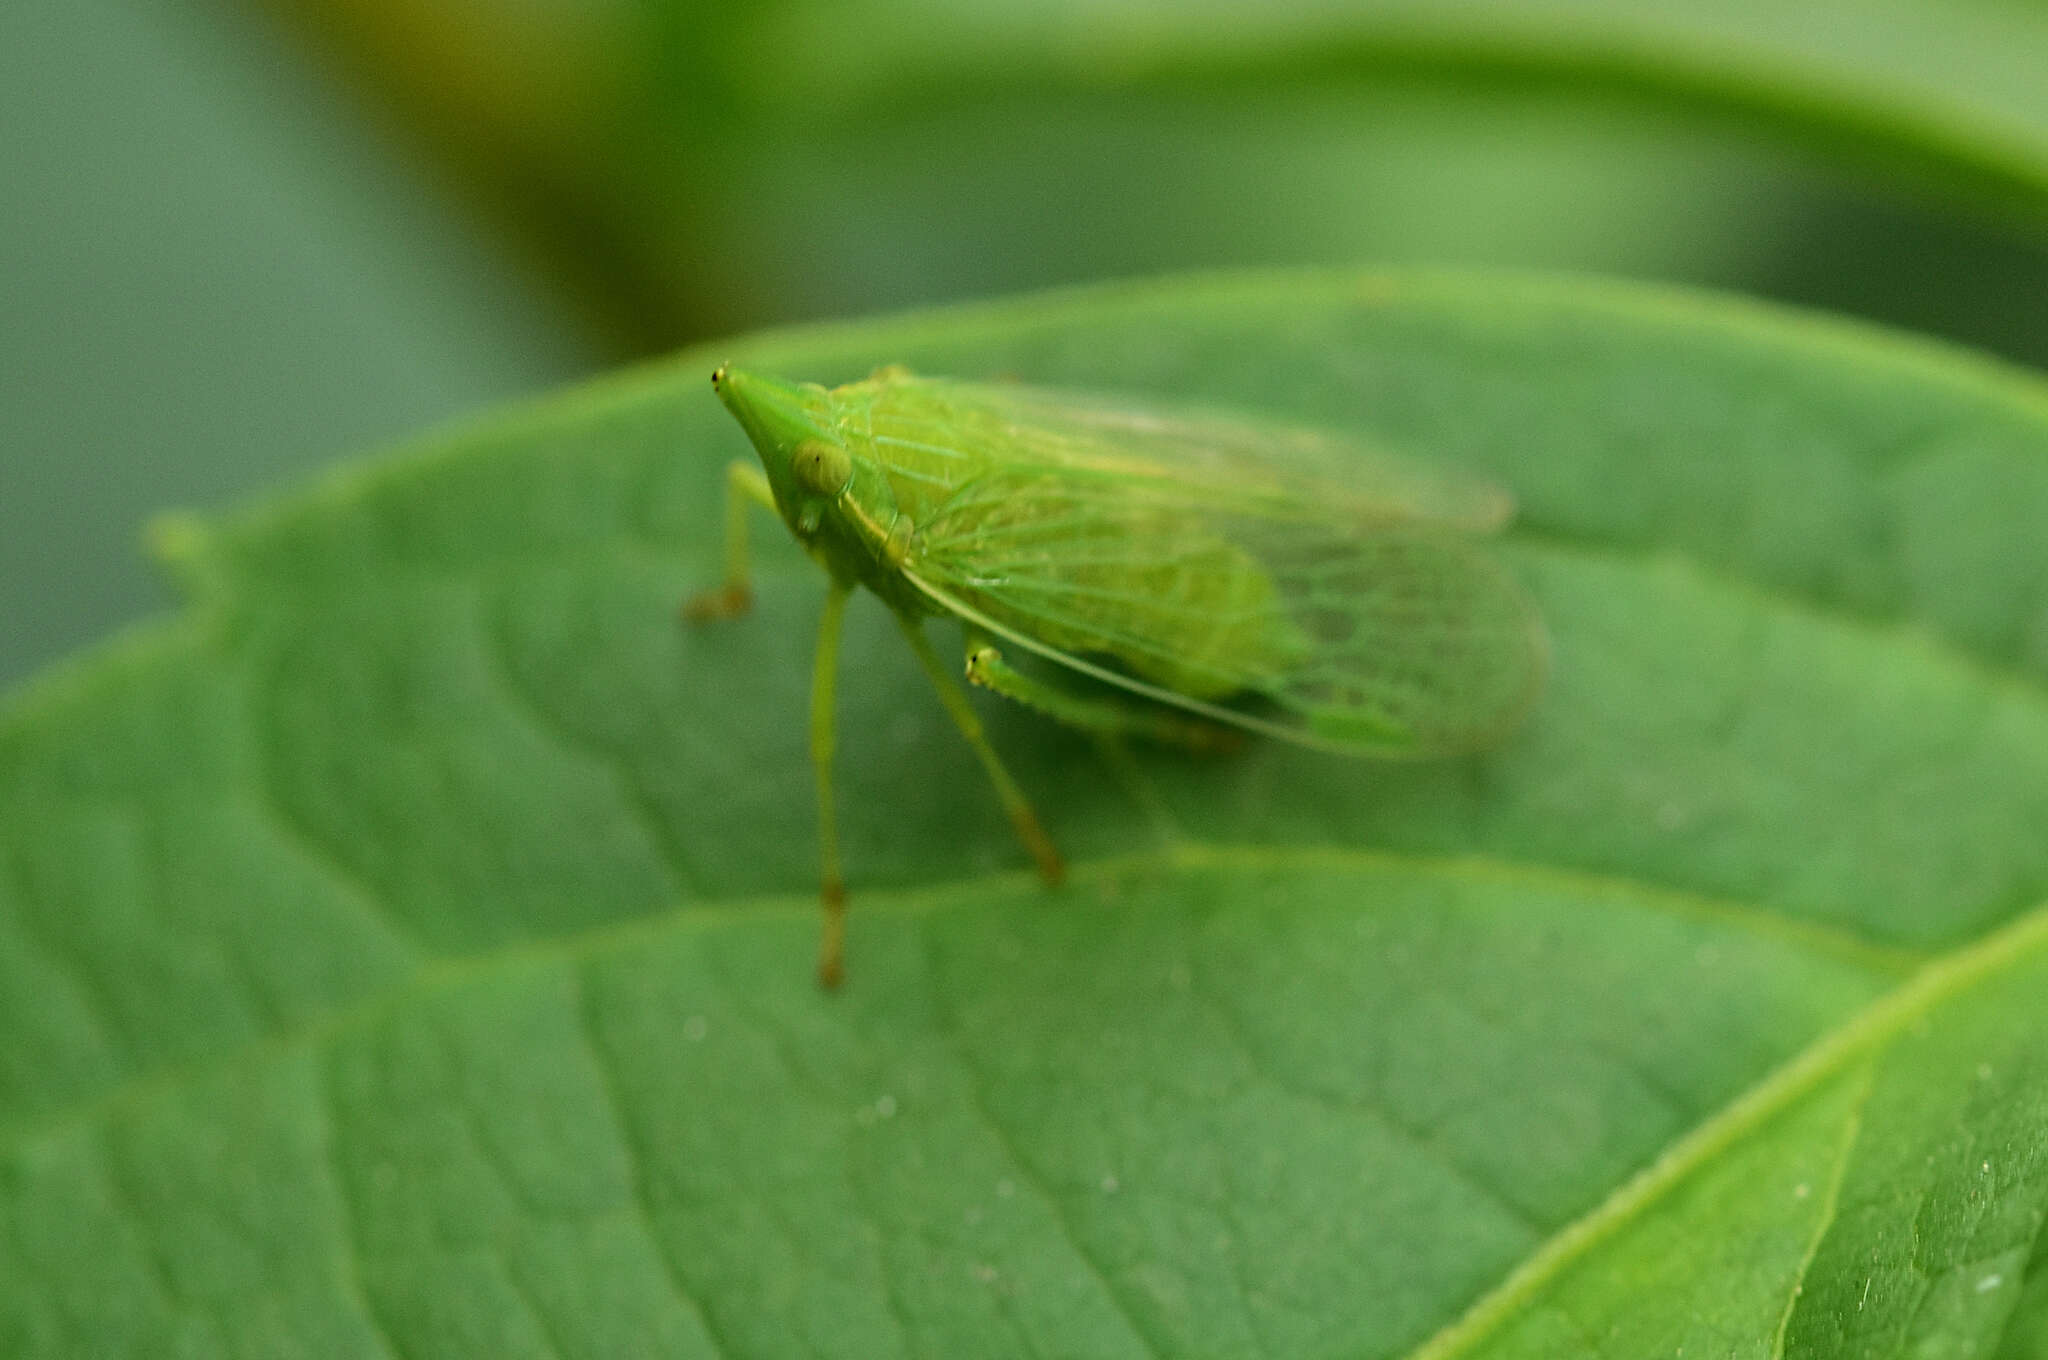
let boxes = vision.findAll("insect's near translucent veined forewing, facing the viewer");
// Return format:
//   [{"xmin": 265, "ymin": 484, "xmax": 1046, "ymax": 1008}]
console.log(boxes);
[{"xmin": 907, "ymin": 463, "xmax": 1544, "ymax": 756}]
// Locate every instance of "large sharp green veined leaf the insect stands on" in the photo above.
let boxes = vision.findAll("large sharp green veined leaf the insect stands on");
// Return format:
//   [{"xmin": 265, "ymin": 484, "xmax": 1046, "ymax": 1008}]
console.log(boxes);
[{"xmin": 0, "ymin": 274, "xmax": 2048, "ymax": 1356}]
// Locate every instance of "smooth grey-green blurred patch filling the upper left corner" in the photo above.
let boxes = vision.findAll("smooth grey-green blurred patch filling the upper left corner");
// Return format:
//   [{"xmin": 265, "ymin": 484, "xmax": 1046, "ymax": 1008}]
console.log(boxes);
[{"xmin": 0, "ymin": 0, "xmax": 604, "ymax": 682}]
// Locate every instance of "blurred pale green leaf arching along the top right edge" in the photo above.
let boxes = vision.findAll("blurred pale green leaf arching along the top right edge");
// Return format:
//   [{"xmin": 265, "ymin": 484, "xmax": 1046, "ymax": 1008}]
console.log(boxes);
[{"xmin": 696, "ymin": 0, "xmax": 2048, "ymax": 209}]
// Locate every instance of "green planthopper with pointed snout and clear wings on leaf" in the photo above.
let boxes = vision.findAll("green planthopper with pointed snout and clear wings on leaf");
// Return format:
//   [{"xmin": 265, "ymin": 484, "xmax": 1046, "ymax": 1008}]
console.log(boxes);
[{"xmin": 686, "ymin": 367, "xmax": 1546, "ymax": 987}]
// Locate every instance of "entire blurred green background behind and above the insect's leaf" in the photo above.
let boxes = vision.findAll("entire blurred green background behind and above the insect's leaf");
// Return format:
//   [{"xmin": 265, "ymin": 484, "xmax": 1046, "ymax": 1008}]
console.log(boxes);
[{"xmin": 12, "ymin": 0, "xmax": 2048, "ymax": 682}]
